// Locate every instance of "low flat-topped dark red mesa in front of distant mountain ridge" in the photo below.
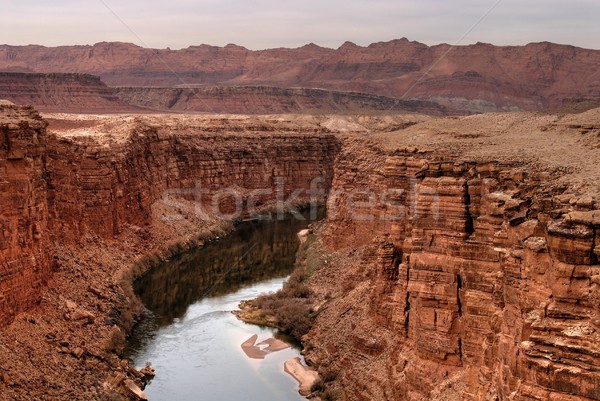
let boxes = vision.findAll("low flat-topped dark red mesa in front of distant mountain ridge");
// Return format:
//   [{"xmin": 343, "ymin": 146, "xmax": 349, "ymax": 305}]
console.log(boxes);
[{"xmin": 0, "ymin": 71, "xmax": 450, "ymax": 115}]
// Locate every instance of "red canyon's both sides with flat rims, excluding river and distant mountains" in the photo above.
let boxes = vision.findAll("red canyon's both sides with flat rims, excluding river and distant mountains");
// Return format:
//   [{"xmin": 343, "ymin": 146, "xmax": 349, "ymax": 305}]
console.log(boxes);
[{"xmin": 0, "ymin": 101, "xmax": 600, "ymax": 401}]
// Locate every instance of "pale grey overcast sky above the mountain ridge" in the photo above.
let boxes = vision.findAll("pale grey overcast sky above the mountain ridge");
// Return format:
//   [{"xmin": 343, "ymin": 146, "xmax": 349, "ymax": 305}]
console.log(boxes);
[{"xmin": 0, "ymin": 0, "xmax": 600, "ymax": 50}]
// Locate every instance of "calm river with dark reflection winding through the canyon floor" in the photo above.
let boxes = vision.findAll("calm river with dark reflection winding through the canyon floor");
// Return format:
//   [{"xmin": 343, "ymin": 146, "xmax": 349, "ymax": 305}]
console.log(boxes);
[{"xmin": 125, "ymin": 211, "xmax": 322, "ymax": 401}]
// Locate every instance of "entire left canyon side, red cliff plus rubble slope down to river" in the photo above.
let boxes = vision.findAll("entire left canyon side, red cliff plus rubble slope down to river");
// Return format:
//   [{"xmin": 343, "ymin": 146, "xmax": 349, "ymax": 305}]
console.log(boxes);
[{"xmin": 0, "ymin": 106, "xmax": 339, "ymax": 401}]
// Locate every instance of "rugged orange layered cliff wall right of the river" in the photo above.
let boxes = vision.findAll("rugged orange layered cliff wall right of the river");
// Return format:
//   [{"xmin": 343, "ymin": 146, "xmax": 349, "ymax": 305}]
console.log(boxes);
[{"xmin": 306, "ymin": 142, "xmax": 600, "ymax": 401}]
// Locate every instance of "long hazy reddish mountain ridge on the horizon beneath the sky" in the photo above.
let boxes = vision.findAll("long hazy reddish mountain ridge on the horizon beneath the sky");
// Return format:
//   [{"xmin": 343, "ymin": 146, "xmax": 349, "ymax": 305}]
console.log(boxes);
[{"xmin": 0, "ymin": 38, "xmax": 600, "ymax": 112}]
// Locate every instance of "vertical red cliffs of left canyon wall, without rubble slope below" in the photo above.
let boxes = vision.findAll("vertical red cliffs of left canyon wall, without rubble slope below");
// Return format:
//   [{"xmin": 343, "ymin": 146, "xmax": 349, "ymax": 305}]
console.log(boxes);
[{"xmin": 0, "ymin": 106, "xmax": 339, "ymax": 326}]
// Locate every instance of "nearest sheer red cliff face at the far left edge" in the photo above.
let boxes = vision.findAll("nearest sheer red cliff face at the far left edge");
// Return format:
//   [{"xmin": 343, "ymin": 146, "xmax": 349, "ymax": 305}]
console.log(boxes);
[{"xmin": 0, "ymin": 105, "xmax": 52, "ymax": 327}]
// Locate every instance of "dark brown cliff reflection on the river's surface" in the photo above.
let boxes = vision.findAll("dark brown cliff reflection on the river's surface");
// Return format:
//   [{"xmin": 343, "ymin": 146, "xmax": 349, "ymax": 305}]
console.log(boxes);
[{"xmin": 134, "ymin": 214, "xmax": 320, "ymax": 327}]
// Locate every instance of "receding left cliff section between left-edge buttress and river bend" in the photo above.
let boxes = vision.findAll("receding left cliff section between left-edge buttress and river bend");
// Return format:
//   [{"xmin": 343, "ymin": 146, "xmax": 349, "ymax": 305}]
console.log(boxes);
[{"xmin": 47, "ymin": 117, "xmax": 339, "ymax": 239}]
